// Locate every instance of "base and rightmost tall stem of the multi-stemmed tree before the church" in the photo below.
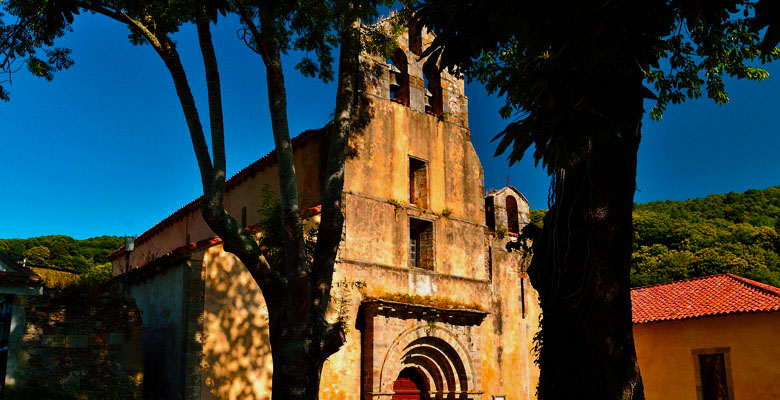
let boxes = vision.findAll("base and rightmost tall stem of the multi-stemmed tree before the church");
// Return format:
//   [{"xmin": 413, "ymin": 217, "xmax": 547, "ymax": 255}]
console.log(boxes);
[{"xmin": 269, "ymin": 10, "xmax": 360, "ymax": 400}]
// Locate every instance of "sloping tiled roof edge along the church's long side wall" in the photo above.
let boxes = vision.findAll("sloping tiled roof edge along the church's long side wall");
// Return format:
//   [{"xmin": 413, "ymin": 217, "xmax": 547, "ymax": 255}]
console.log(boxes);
[{"xmin": 106, "ymin": 126, "xmax": 327, "ymax": 260}]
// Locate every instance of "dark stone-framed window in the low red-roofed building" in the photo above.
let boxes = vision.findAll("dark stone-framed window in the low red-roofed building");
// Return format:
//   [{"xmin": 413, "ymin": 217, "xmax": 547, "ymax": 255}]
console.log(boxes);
[{"xmin": 693, "ymin": 347, "xmax": 734, "ymax": 400}]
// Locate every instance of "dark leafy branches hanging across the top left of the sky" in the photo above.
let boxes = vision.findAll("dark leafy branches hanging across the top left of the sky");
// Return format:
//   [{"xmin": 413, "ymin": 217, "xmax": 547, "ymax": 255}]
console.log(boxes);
[{"xmin": 0, "ymin": 0, "xmax": 396, "ymax": 101}]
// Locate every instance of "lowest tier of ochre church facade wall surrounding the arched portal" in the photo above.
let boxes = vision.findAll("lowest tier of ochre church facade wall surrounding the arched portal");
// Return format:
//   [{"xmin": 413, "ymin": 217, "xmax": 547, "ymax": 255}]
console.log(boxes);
[{"xmin": 320, "ymin": 250, "xmax": 540, "ymax": 400}]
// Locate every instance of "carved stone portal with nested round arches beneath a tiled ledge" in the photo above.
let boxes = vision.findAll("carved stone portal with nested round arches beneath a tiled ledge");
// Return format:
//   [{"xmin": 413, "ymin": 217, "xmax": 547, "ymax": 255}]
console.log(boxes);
[{"xmin": 362, "ymin": 302, "xmax": 486, "ymax": 400}]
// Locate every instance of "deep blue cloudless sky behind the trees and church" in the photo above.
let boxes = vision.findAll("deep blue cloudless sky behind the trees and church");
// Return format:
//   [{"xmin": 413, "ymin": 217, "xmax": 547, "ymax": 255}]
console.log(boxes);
[{"xmin": 0, "ymin": 16, "xmax": 780, "ymax": 238}]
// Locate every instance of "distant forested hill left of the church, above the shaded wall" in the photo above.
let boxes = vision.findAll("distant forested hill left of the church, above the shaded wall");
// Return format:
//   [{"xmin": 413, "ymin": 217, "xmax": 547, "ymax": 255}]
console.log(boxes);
[{"xmin": 0, "ymin": 235, "xmax": 124, "ymax": 272}]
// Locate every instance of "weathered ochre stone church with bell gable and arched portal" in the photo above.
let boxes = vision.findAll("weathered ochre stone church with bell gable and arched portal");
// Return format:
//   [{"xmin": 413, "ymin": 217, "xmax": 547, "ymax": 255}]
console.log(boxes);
[{"xmin": 109, "ymin": 24, "xmax": 539, "ymax": 400}]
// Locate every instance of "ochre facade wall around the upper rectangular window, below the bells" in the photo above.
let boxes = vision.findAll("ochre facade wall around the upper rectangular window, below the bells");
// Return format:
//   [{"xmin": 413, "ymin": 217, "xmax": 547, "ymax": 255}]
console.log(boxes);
[{"xmin": 344, "ymin": 98, "xmax": 484, "ymax": 224}]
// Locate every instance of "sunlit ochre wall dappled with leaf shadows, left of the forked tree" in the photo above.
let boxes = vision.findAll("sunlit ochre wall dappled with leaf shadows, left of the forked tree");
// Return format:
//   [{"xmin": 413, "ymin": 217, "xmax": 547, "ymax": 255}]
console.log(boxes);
[{"xmin": 202, "ymin": 246, "xmax": 273, "ymax": 400}]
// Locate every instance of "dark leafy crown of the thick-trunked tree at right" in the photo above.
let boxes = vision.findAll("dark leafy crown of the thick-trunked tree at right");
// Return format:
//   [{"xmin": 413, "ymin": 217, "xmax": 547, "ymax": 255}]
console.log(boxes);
[{"xmin": 417, "ymin": 0, "xmax": 780, "ymax": 174}]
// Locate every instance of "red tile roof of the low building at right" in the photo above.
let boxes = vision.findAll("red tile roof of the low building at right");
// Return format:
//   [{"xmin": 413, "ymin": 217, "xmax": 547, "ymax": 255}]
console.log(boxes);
[{"xmin": 631, "ymin": 274, "xmax": 780, "ymax": 324}]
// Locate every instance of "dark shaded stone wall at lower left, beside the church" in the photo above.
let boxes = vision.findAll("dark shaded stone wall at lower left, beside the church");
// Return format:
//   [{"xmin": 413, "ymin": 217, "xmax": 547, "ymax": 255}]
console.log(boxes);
[{"xmin": 5, "ymin": 293, "xmax": 144, "ymax": 399}]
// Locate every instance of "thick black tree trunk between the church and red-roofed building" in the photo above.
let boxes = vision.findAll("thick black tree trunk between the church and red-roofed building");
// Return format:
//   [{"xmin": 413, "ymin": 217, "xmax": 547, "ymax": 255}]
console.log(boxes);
[{"xmin": 529, "ymin": 121, "xmax": 644, "ymax": 400}]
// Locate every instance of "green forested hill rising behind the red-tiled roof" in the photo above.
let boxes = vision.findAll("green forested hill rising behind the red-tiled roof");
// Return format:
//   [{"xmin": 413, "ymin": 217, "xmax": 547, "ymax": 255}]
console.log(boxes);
[{"xmin": 532, "ymin": 186, "xmax": 780, "ymax": 286}]
